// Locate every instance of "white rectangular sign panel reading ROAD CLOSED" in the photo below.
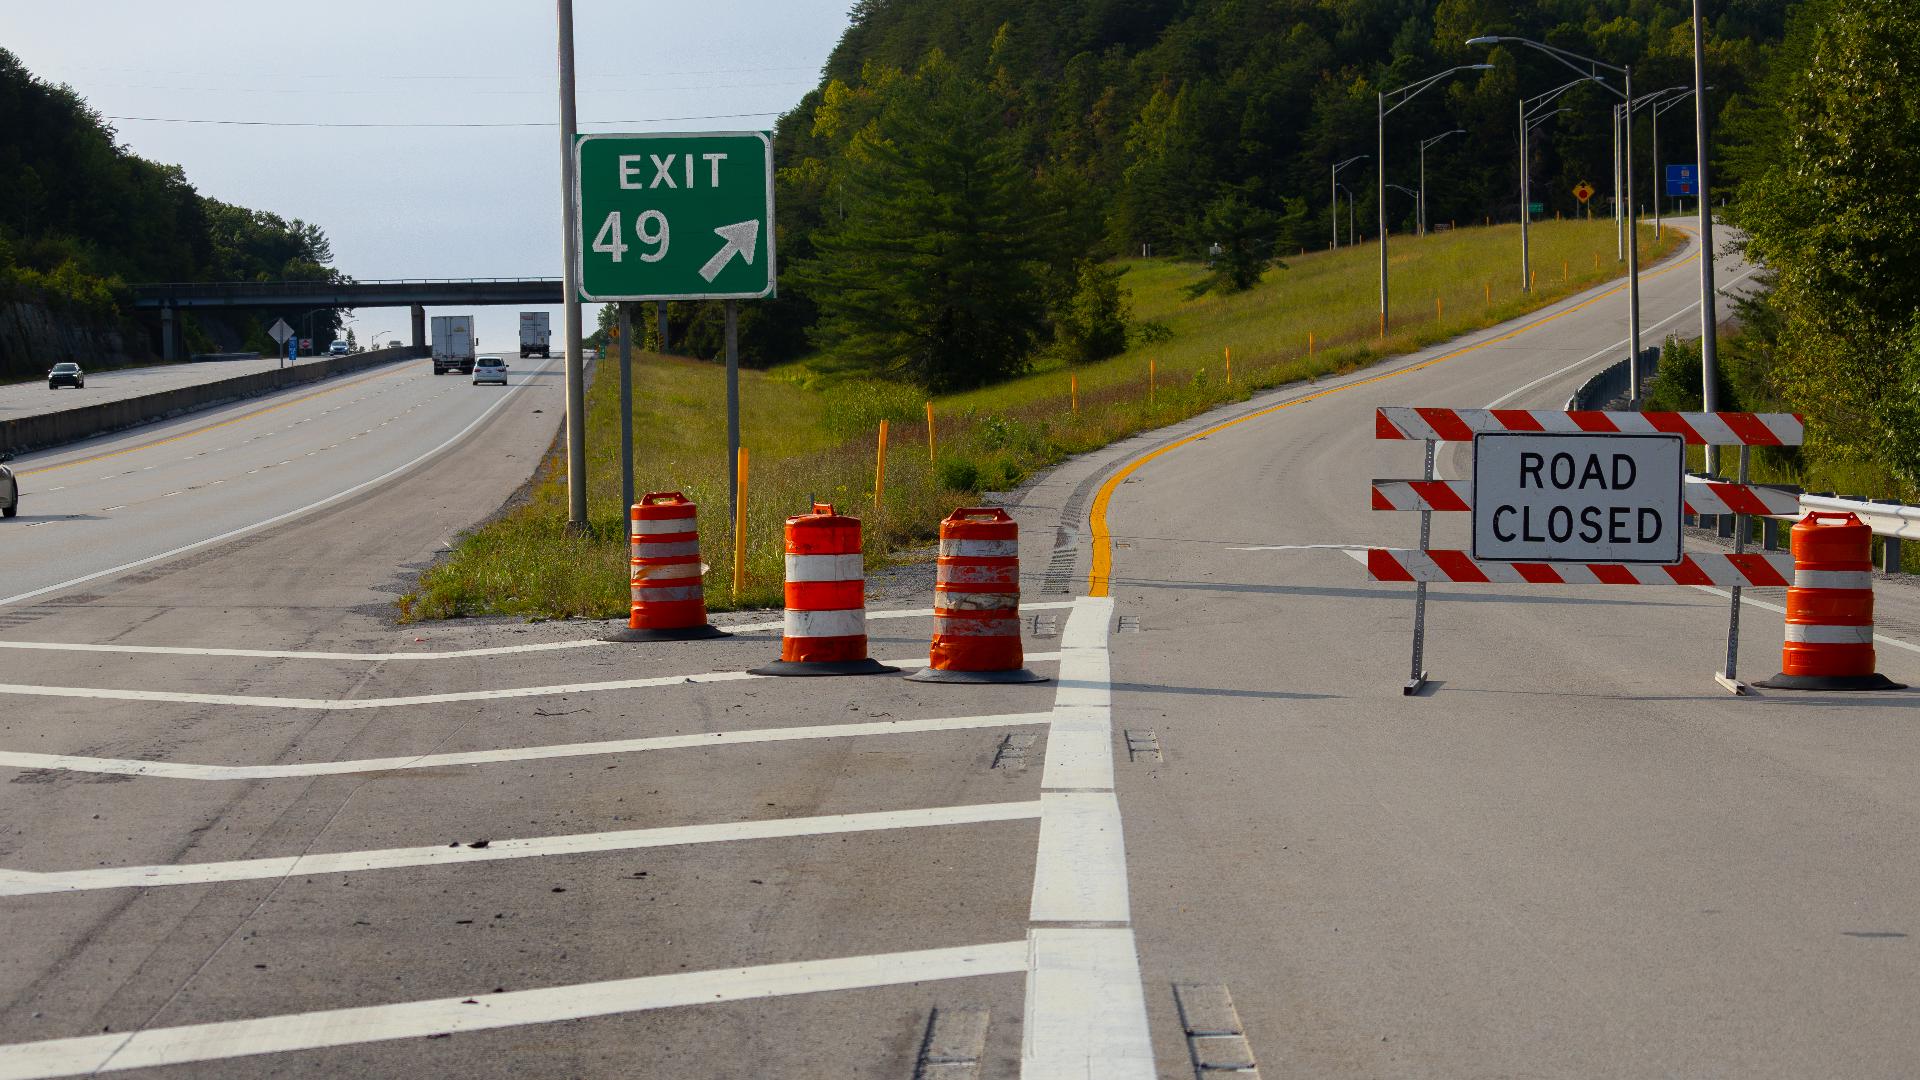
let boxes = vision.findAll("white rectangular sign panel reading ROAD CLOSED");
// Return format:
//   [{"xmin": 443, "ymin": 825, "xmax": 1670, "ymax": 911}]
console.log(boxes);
[{"xmin": 1473, "ymin": 432, "xmax": 1686, "ymax": 565}]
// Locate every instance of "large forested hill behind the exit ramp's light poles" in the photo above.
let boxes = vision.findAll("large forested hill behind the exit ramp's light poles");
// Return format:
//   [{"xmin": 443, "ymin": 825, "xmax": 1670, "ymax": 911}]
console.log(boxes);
[{"xmin": 721, "ymin": 0, "xmax": 1789, "ymax": 380}]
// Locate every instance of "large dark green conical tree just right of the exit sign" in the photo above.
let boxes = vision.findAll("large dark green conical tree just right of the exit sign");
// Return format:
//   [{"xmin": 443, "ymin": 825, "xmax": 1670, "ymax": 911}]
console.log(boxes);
[{"xmin": 791, "ymin": 54, "xmax": 1058, "ymax": 390}]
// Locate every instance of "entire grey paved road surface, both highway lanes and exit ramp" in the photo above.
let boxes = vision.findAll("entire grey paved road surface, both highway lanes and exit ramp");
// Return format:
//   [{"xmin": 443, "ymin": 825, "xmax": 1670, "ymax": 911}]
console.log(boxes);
[{"xmin": 0, "ymin": 222, "xmax": 1920, "ymax": 1080}]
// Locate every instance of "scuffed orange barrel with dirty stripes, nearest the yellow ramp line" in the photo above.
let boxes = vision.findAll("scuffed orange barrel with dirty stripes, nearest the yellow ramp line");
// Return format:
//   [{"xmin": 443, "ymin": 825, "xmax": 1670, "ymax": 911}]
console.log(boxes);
[{"xmin": 908, "ymin": 507, "xmax": 1046, "ymax": 682}]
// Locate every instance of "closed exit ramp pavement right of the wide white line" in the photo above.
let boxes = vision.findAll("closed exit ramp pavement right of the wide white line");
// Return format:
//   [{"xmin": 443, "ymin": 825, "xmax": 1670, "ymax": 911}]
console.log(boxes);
[{"xmin": 1029, "ymin": 220, "xmax": 1920, "ymax": 1078}]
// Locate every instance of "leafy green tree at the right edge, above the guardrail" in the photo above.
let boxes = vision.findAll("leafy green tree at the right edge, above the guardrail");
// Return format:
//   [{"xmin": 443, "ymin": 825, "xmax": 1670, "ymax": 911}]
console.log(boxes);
[{"xmin": 1736, "ymin": 0, "xmax": 1920, "ymax": 486}]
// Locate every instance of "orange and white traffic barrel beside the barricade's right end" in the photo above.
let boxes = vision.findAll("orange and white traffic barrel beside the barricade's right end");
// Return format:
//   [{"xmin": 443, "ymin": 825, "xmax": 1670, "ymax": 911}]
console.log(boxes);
[{"xmin": 1755, "ymin": 509, "xmax": 1901, "ymax": 690}]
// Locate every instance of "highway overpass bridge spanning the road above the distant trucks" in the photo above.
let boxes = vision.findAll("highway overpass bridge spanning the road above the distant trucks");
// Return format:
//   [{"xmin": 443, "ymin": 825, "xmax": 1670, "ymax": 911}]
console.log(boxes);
[{"xmin": 132, "ymin": 277, "xmax": 564, "ymax": 359}]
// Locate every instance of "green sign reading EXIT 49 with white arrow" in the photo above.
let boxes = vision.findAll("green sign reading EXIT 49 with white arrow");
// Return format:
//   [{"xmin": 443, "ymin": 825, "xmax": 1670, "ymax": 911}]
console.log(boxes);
[{"xmin": 574, "ymin": 131, "xmax": 774, "ymax": 302}]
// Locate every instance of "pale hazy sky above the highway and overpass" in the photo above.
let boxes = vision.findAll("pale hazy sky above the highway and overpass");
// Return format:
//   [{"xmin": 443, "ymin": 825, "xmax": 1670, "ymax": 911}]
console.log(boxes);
[{"xmin": 0, "ymin": 0, "xmax": 852, "ymax": 352}]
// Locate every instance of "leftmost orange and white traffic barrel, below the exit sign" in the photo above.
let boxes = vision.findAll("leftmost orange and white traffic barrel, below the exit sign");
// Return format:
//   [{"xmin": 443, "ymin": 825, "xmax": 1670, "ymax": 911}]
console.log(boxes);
[{"xmin": 607, "ymin": 492, "xmax": 726, "ymax": 642}]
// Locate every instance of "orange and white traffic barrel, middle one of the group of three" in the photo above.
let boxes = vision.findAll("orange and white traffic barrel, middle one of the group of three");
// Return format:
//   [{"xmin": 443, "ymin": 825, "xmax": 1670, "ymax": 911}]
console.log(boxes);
[{"xmin": 753, "ymin": 503, "xmax": 900, "ymax": 675}]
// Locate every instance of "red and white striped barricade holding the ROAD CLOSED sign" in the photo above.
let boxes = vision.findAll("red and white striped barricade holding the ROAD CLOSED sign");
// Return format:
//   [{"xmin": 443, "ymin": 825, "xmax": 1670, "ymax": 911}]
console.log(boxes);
[{"xmin": 1365, "ymin": 407, "xmax": 1805, "ymax": 694}]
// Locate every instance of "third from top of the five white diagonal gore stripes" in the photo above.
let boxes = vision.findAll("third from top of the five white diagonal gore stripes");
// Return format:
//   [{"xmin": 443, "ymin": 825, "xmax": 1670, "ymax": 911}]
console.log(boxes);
[{"xmin": 0, "ymin": 713, "xmax": 1052, "ymax": 780}]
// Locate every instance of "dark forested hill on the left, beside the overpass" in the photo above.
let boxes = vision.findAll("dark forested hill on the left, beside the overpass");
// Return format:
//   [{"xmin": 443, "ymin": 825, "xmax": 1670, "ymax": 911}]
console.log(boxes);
[{"xmin": 0, "ymin": 48, "xmax": 336, "ymax": 375}]
